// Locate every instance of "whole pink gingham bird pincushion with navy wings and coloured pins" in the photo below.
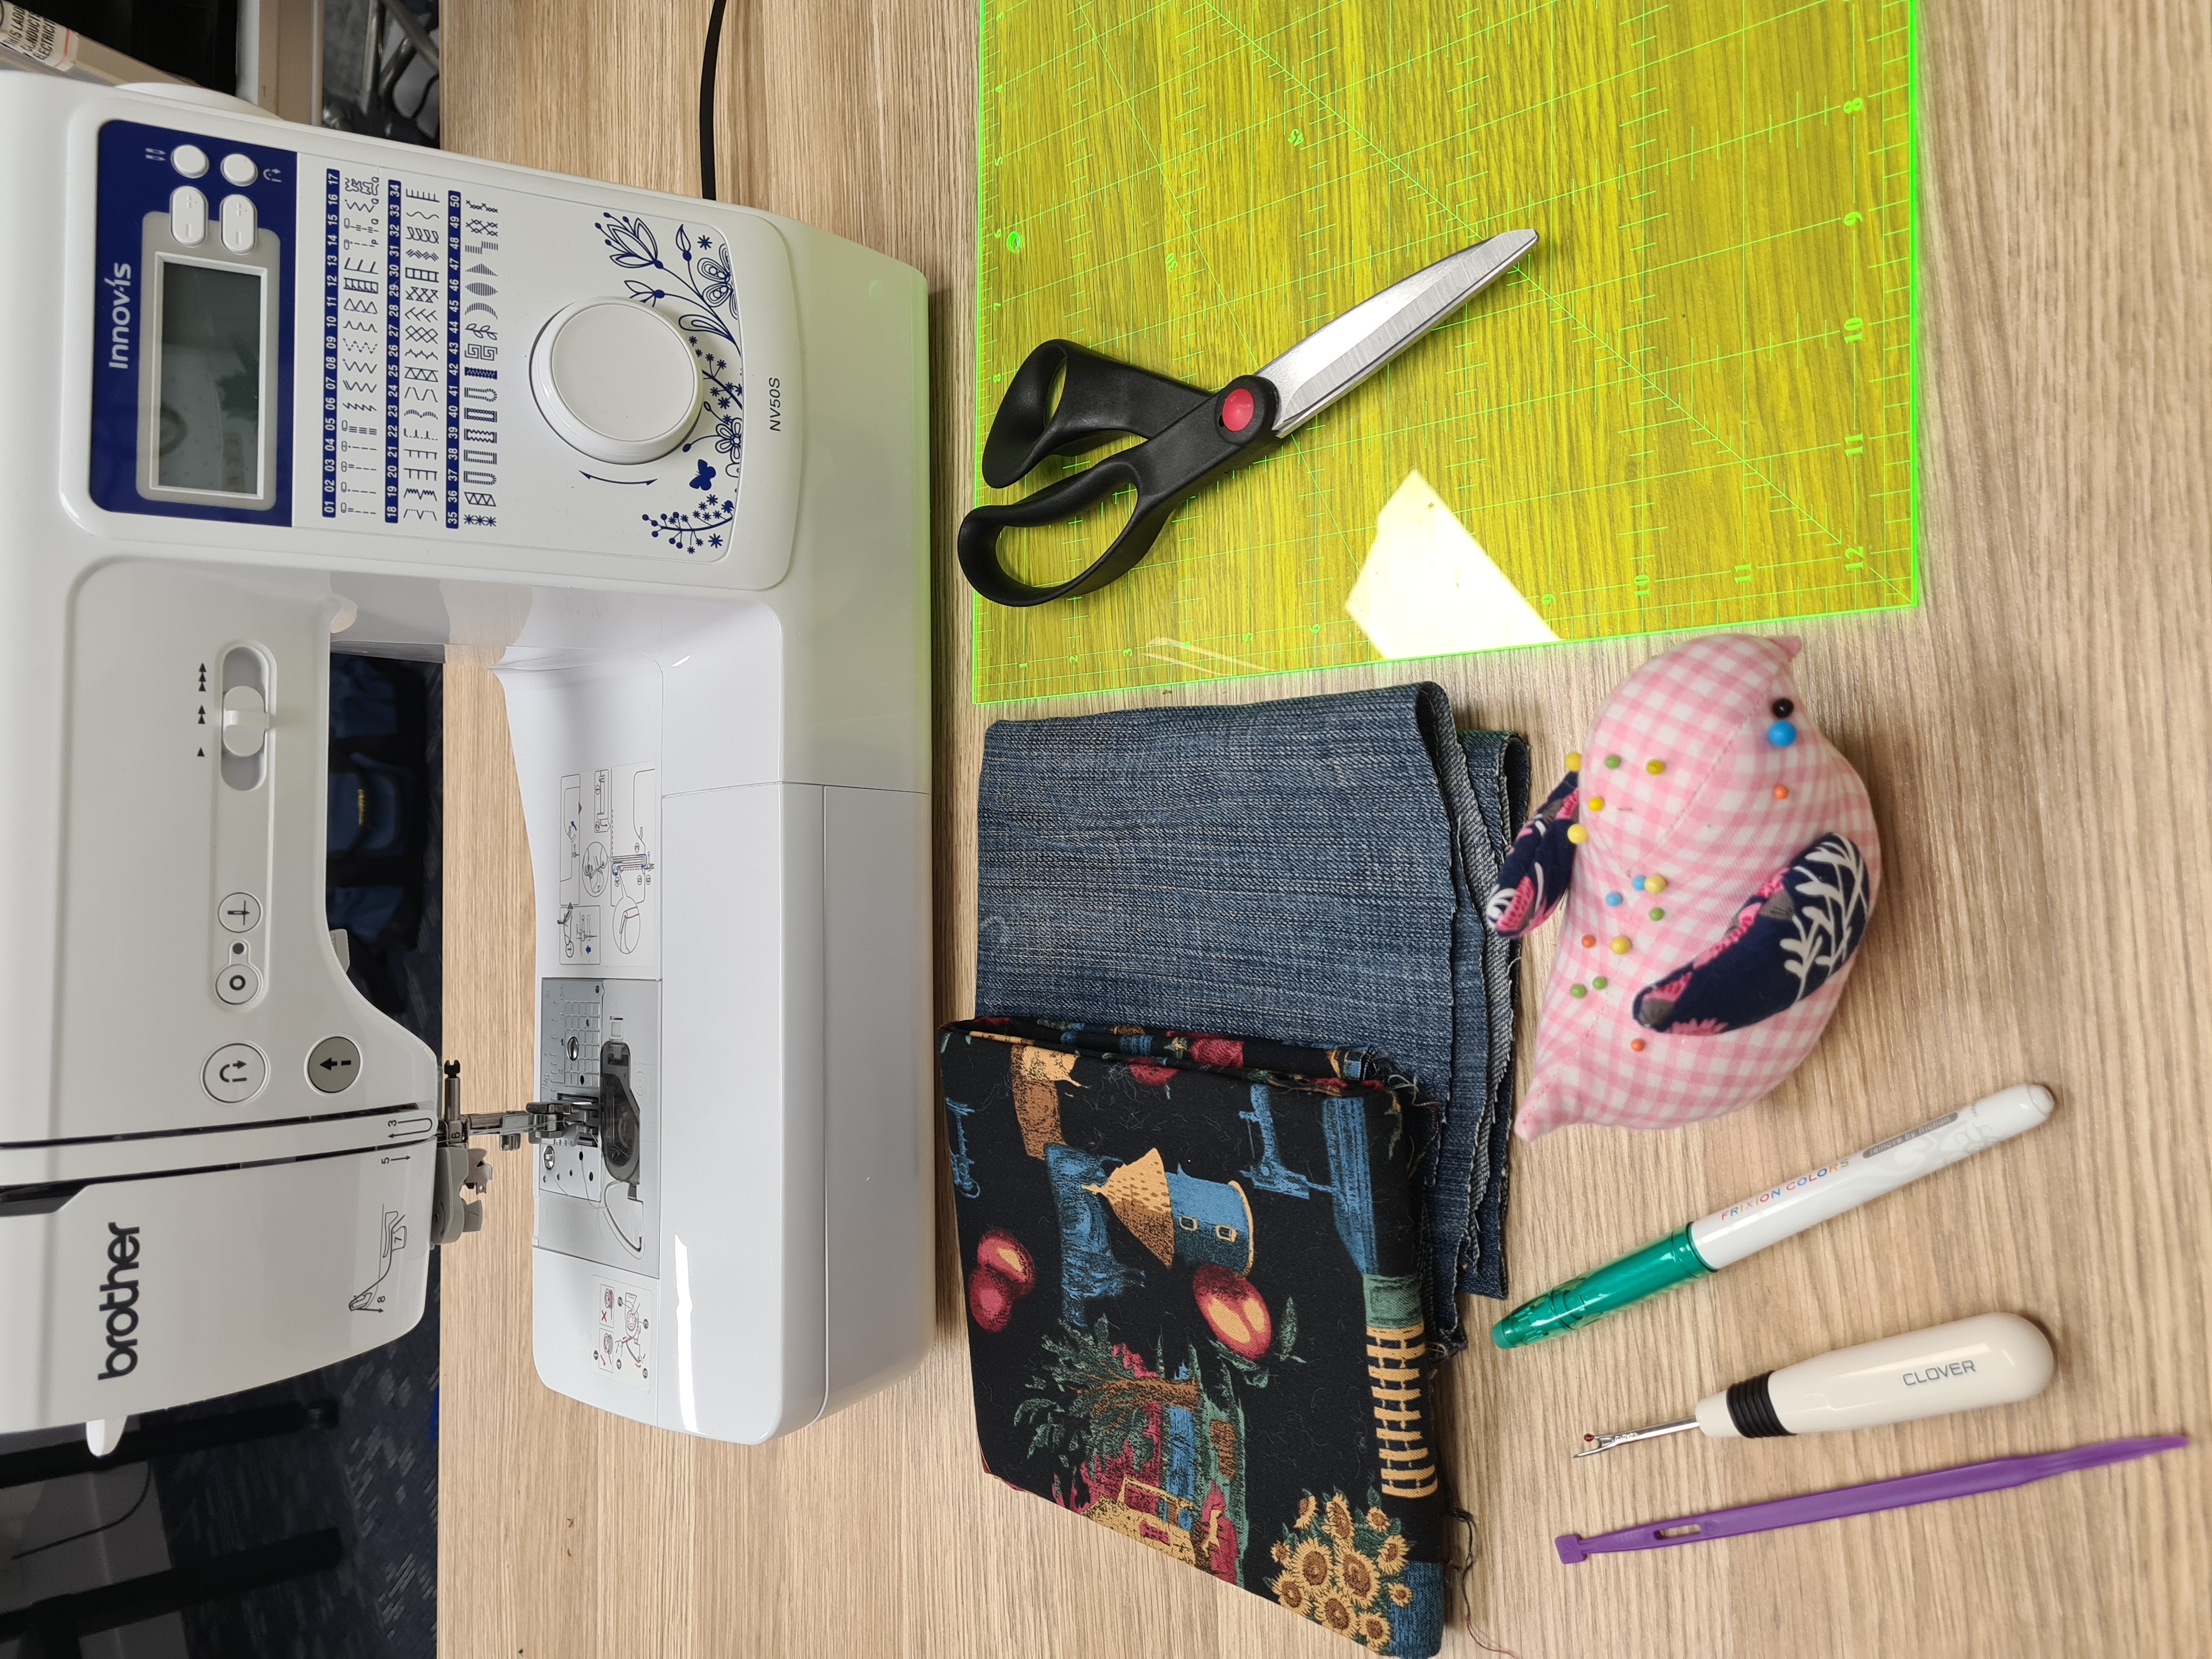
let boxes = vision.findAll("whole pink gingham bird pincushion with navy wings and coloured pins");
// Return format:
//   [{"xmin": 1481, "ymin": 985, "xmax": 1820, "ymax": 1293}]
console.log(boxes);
[{"xmin": 1487, "ymin": 635, "xmax": 1882, "ymax": 1139}]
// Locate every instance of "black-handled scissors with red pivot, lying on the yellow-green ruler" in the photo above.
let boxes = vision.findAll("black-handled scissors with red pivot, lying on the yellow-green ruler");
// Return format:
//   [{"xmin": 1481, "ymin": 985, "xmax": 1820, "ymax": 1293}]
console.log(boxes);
[{"xmin": 958, "ymin": 230, "xmax": 1535, "ymax": 606}]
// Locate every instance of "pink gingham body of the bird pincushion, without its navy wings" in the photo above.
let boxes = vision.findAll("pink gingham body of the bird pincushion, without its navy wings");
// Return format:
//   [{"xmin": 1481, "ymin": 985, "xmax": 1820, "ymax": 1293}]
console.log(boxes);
[{"xmin": 1517, "ymin": 635, "xmax": 1882, "ymax": 1139}]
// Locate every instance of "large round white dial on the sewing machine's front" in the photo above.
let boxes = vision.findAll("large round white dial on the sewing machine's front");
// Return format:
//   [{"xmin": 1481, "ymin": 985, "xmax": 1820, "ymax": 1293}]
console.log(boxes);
[{"xmin": 531, "ymin": 298, "xmax": 699, "ymax": 467}]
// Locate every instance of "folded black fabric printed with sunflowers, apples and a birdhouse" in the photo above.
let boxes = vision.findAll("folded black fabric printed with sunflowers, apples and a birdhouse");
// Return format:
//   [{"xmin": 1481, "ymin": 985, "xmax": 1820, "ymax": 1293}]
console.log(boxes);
[{"xmin": 938, "ymin": 1018, "xmax": 1449, "ymax": 1655}]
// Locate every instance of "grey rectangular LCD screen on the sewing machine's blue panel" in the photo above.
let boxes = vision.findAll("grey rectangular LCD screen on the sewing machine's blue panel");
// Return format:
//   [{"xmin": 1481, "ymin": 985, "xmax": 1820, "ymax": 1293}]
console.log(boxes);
[{"xmin": 155, "ymin": 259, "xmax": 263, "ymax": 495}]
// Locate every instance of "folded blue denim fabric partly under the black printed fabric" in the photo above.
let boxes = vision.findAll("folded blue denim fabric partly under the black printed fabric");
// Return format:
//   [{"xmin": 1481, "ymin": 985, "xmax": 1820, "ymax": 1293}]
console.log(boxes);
[{"xmin": 975, "ymin": 684, "xmax": 1528, "ymax": 1354}]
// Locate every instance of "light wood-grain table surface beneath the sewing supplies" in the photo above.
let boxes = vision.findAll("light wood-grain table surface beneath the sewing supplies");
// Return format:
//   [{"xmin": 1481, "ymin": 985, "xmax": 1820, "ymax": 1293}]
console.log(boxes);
[{"xmin": 440, "ymin": 0, "xmax": 2212, "ymax": 1659}]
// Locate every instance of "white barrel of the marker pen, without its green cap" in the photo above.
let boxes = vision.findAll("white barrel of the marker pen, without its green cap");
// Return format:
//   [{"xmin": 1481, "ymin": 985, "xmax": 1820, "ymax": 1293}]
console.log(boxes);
[{"xmin": 1690, "ymin": 1084, "xmax": 2053, "ymax": 1267}]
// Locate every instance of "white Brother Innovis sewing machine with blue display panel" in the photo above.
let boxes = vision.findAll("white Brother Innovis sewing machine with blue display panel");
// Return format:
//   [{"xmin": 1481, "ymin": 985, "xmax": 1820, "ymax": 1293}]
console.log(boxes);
[{"xmin": 0, "ymin": 75, "xmax": 931, "ymax": 1451}]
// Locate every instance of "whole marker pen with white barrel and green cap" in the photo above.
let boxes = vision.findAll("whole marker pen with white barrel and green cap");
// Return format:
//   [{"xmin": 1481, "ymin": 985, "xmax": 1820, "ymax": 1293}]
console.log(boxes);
[{"xmin": 1491, "ymin": 1084, "xmax": 2053, "ymax": 1347}]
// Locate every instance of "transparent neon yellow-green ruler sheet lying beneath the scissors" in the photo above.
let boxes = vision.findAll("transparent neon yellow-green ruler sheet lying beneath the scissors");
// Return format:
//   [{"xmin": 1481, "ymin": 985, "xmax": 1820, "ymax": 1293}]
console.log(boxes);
[{"xmin": 975, "ymin": 0, "xmax": 1916, "ymax": 701}]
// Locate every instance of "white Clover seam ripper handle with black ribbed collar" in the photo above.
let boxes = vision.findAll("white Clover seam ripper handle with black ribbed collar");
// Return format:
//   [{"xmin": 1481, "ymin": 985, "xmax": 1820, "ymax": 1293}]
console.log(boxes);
[{"xmin": 1697, "ymin": 1314, "xmax": 2053, "ymax": 1440}]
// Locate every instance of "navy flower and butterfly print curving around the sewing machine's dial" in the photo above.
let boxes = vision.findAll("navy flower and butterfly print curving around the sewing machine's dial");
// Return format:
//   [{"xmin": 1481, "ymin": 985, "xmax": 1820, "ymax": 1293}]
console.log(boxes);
[{"xmin": 593, "ymin": 212, "xmax": 746, "ymax": 553}]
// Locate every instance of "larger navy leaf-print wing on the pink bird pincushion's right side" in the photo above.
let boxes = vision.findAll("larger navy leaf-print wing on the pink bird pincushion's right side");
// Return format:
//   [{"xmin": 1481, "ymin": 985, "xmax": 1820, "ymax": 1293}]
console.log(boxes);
[{"xmin": 1635, "ymin": 834, "xmax": 1874, "ymax": 1037}]
